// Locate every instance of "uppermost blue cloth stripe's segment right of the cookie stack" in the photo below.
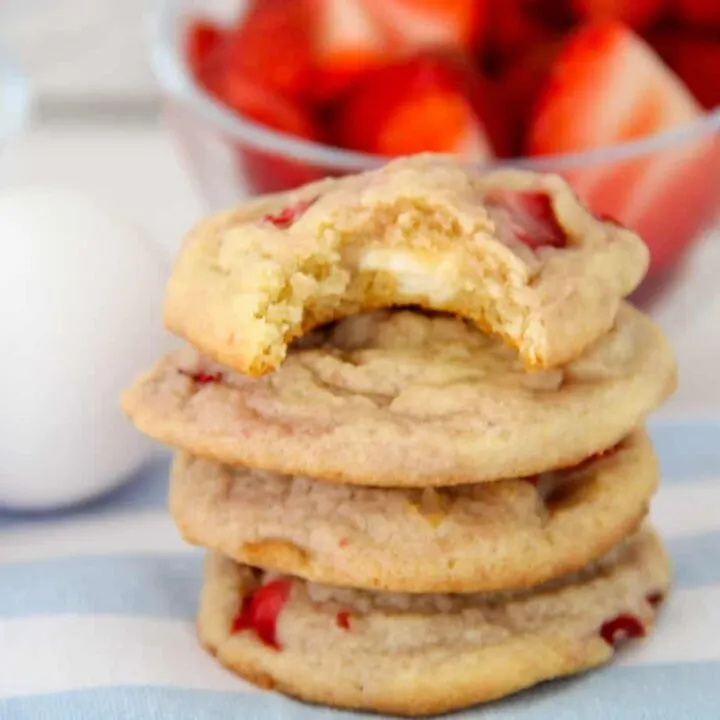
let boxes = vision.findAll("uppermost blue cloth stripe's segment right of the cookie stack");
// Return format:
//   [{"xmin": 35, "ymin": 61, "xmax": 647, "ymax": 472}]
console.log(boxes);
[{"xmin": 648, "ymin": 420, "xmax": 720, "ymax": 482}]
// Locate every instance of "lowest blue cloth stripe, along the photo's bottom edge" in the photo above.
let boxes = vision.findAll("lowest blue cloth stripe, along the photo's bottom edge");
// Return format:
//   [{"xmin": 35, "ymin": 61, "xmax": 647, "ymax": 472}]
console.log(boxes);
[{"xmin": 0, "ymin": 662, "xmax": 720, "ymax": 720}]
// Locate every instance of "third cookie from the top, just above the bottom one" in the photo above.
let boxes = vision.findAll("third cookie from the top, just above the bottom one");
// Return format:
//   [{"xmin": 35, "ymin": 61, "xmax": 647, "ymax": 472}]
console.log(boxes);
[{"xmin": 170, "ymin": 432, "xmax": 658, "ymax": 592}]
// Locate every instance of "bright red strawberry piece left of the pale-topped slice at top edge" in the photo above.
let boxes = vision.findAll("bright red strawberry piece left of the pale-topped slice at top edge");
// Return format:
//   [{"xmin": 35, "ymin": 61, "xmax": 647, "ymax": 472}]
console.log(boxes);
[{"xmin": 223, "ymin": 0, "xmax": 312, "ymax": 98}]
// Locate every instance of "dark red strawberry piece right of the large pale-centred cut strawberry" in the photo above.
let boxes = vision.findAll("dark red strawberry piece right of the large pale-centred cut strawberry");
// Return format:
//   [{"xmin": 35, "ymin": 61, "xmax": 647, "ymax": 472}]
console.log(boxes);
[{"xmin": 650, "ymin": 32, "xmax": 720, "ymax": 110}]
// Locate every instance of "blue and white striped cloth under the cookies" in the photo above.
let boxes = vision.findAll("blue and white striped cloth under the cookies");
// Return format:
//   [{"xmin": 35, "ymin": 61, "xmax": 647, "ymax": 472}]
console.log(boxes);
[{"xmin": 0, "ymin": 421, "xmax": 720, "ymax": 720}]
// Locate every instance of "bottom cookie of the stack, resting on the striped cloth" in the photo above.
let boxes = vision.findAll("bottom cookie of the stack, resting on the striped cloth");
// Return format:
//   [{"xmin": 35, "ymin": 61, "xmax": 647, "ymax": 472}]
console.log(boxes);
[{"xmin": 198, "ymin": 530, "xmax": 670, "ymax": 716}]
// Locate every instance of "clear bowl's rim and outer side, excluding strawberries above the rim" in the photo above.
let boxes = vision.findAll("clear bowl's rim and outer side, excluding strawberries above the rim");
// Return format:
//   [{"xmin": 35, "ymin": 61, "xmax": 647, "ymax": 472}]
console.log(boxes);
[{"xmin": 149, "ymin": 0, "xmax": 720, "ymax": 287}]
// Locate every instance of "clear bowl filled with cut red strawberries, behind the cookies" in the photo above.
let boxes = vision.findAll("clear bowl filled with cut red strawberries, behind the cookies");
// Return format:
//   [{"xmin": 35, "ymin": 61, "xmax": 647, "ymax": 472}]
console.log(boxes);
[{"xmin": 152, "ymin": 0, "xmax": 720, "ymax": 276}]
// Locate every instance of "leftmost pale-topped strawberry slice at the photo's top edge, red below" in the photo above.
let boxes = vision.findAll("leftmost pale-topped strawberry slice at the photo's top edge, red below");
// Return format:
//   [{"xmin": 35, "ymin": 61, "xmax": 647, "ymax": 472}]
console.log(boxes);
[{"xmin": 309, "ymin": 0, "xmax": 398, "ymax": 102}]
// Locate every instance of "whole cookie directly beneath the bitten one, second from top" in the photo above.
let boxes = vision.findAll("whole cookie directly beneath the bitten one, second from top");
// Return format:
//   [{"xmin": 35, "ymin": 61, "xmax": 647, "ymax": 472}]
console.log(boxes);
[{"xmin": 123, "ymin": 305, "xmax": 676, "ymax": 487}]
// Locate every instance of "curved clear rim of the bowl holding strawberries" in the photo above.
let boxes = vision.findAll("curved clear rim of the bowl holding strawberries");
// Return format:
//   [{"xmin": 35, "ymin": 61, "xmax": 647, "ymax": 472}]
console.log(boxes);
[{"xmin": 146, "ymin": 0, "xmax": 720, "ymax": 171}]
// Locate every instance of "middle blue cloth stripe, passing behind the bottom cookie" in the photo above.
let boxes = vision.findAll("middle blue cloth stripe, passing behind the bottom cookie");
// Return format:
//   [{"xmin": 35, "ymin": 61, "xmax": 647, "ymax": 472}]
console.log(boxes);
[{"xmin": 0, "ymin": 532, "xmax": 720, "ymax": 619}]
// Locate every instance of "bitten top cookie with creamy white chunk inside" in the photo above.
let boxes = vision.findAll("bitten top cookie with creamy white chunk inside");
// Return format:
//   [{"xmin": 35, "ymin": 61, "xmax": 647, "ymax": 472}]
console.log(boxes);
[{"xmin": 165, "ymin": 155, "xmax": 648, "ymax": 375}]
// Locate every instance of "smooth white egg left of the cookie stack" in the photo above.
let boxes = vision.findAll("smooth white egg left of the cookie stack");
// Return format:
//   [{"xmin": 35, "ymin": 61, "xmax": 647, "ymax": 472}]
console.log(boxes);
[{"xmin": 0, "ymin": 187, "xmax": 170, "ymax": 509}]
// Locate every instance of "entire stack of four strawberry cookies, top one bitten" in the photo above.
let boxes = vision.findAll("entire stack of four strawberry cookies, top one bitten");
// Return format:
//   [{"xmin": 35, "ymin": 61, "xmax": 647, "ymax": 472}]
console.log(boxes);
[{"xmin": 123, "ymin": 156, "xmax": 675, "ymax": 715}]
